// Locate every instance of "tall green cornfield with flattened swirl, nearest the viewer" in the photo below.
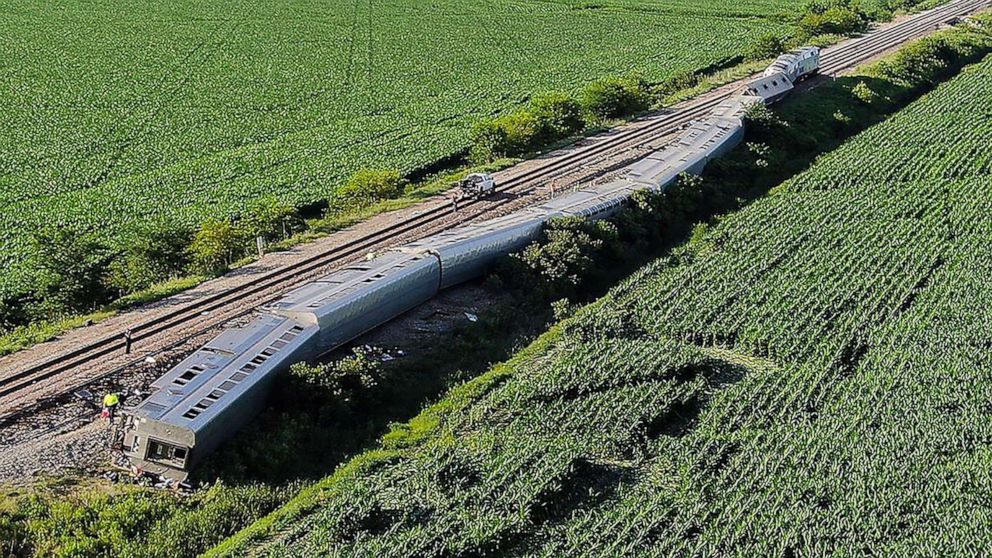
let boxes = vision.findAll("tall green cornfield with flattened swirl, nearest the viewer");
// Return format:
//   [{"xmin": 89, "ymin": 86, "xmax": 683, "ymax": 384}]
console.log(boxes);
[{"xmin": 219, "ymin": 54, "xmax": 992, "ymax": 557}]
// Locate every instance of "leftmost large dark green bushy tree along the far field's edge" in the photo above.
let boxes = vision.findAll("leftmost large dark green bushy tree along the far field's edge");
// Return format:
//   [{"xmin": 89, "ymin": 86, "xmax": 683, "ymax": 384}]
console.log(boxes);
[{"xmin": 31, "ymin": 227, "xmax": 112, "ymax": 312}]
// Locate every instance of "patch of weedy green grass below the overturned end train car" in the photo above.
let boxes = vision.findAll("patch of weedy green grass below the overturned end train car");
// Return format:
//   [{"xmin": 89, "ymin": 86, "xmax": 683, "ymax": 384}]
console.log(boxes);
[{"xmin": 0, "ymin": 478, "xmax": 296, "ymax": 558}]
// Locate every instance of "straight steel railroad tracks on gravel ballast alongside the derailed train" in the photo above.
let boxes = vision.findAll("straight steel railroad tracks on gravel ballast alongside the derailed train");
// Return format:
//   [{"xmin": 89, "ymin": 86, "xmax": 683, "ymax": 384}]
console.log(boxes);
[{"xmin": 0, "ymin": 0, "xmax": 992, "ymax": 424}]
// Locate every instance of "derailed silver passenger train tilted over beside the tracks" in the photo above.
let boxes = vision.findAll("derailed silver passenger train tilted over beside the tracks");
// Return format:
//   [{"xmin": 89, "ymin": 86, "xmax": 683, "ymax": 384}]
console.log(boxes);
[{"xmin": 122, "ymin": 49, "xmax": 819, "ymax": 481}]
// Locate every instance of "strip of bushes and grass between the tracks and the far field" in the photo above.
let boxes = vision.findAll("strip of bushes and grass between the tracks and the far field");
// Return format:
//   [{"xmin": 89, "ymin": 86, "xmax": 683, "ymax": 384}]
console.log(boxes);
[{"xmin": 0, "ymin": 1, "xmax": 940, "ymax": 356}]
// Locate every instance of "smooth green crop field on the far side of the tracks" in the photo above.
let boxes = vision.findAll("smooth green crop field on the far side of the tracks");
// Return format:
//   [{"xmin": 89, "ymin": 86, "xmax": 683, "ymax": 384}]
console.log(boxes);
[{"xmin": 0, "ymin": 0, "xmax": 801, "ymax": 294}]
